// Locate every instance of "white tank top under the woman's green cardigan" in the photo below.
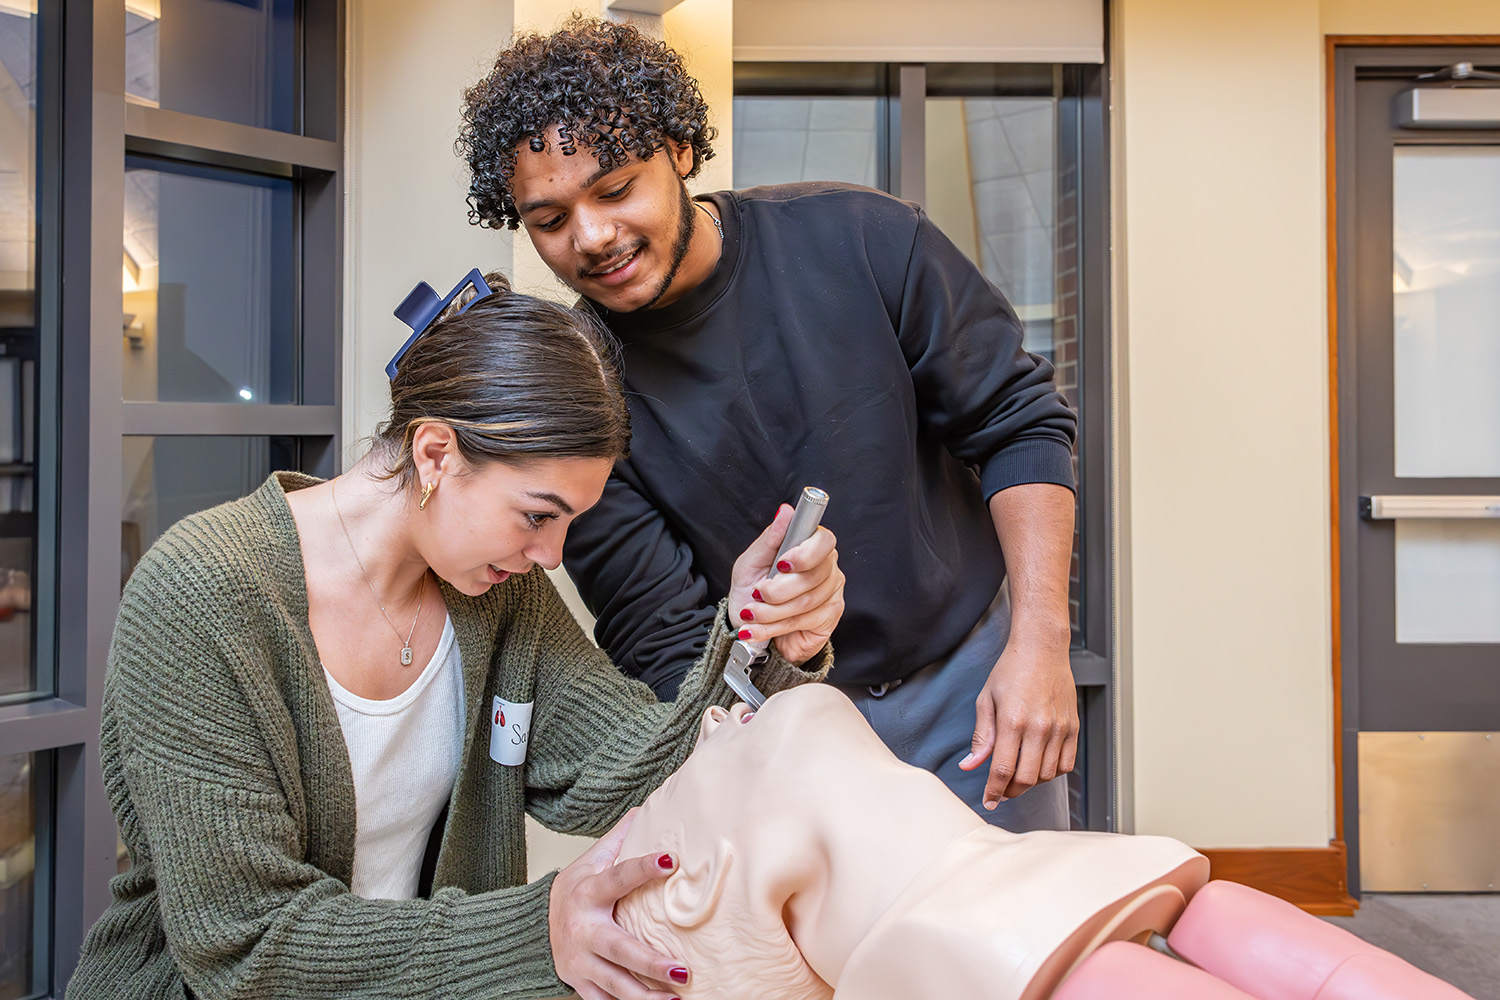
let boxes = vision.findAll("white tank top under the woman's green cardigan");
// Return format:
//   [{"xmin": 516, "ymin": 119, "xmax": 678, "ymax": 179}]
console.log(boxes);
[{"xmin": 323, "ymin": 618, "xmax": 464, "ymax": 900}]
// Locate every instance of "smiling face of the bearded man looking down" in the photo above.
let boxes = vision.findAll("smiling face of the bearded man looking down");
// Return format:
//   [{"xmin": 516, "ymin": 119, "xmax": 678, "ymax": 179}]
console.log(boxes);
[{"xmin": 510, "ymin": 127, "xmax": 719, "ymax": 312}]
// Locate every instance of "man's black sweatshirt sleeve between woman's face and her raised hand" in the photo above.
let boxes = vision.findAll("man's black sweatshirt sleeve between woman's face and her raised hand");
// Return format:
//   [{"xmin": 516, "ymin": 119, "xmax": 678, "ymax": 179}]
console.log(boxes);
[{"xmin": 563, "ymin": 460, "xmax": 716, "ymax": 702}]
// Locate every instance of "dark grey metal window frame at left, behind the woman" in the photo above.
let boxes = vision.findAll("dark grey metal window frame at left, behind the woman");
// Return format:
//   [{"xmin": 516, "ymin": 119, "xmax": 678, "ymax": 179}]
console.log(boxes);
[{"xmin": 0, "ymin": 0, "xmax": 345, "ymax": 997}]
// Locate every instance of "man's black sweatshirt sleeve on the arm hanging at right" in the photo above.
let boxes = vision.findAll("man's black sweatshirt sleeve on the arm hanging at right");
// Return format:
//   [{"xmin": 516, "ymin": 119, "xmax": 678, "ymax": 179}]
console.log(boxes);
[{"xmin": 887, "ymin": 210, "xmax": 1077, "ymax": 501}]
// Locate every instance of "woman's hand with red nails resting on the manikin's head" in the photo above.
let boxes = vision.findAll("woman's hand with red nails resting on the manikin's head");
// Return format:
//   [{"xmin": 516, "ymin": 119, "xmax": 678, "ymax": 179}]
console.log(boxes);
[{"xmin": 548, "ymin": 810, "xmax": 687, "ymax": 1000}]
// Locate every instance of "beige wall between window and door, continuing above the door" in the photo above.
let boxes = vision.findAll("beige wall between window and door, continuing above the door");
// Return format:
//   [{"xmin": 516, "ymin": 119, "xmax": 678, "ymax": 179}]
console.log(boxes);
[{"xmin": 1113, "ymin": 0, "xmax": 1500, "ymax": 847}]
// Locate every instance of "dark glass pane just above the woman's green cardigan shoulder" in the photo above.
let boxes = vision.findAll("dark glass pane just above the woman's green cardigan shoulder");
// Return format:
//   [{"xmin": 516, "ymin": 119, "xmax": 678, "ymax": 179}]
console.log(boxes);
[{"xmin": 120, "ymin": 436, "xmax": 299, "ymax": 585}]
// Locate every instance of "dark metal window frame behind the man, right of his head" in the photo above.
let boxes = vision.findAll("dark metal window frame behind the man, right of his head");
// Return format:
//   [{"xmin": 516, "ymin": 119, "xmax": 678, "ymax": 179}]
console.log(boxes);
[{"xmin": 735, "ymin": 63, "xmax": 1119, "ymax": 831}]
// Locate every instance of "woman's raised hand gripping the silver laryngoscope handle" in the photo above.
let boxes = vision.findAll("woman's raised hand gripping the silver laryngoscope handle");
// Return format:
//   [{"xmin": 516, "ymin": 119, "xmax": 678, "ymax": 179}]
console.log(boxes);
[{"xmin": 729, "ymin": 504, "xmax": 845, "ymax": 664}]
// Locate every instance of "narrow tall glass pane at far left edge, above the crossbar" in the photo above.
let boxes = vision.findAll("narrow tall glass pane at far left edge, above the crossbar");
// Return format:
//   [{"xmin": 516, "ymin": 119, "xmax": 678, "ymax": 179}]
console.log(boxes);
[{"xmin": 0, "ymin": 3, "xmax": 39, "ymax": 704}]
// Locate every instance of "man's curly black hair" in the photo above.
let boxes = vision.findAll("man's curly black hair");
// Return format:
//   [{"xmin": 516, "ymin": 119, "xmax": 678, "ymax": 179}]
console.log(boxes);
[{"xmin": 455, "ymin": 12, "xmax": 717, "ymax": 229}]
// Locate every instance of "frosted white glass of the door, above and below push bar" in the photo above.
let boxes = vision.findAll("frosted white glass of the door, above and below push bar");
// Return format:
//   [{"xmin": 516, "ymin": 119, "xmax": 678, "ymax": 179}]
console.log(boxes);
[{"xmin": 1391, "ymin": 145, "xmax": 1500, "ymax": 643}]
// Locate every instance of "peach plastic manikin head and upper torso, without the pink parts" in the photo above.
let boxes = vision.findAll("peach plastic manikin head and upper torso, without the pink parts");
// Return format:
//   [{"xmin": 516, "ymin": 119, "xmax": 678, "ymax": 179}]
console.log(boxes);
[{"xmin": 617, "ymin": 685, "xmax": 1208, "ymax": 1000}]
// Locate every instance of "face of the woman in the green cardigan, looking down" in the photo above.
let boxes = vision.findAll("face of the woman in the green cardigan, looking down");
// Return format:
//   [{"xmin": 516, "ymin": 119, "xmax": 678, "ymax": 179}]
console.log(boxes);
[{"xmin": 414, "ymin": 453, "xmax": 614, "ymax": 597}]
